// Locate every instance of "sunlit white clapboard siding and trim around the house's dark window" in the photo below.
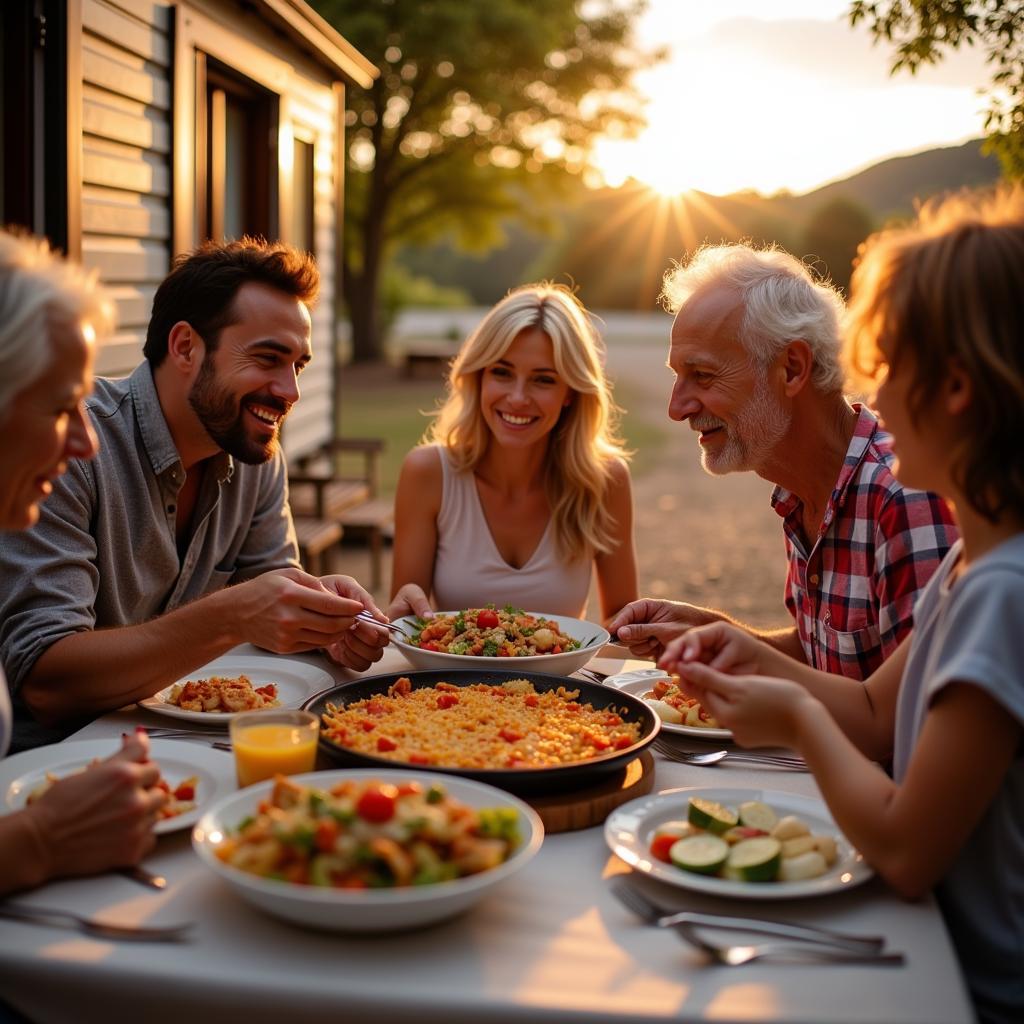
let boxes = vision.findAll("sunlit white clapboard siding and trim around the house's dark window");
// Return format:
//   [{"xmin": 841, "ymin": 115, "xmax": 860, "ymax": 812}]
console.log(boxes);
[{"xmin": 75, "ymin": 0, "xmax": 346, "ymax": 455}]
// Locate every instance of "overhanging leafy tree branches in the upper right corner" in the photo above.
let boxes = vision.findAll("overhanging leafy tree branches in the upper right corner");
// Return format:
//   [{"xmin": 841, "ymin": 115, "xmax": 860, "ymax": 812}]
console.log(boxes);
[{"xmin": 849, "ymin": 0, "xmax": 1024, "ymax": 178}]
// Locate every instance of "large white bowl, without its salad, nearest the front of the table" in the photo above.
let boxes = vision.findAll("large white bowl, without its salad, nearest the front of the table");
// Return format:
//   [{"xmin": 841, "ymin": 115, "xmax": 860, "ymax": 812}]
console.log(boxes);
[{"xmin": 193, "ymin": 769, "xmax": 544, "ymax": 932}]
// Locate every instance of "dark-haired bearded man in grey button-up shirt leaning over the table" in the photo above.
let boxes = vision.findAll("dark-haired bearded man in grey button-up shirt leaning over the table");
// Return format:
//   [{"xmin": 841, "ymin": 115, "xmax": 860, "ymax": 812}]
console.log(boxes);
[{"xmin": 0, "ymin": 239, "xmax": 387, "ymax": 749}]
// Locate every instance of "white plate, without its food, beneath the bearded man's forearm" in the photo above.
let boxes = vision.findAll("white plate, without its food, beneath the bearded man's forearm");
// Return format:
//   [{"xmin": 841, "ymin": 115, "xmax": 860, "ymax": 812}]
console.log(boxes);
[{"xmin": 138, "ymin": 654, "xmax": 334, "ymax": 727}]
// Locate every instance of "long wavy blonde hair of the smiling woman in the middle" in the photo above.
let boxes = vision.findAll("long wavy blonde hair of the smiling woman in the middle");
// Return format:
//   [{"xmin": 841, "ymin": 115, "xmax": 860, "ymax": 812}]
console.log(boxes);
[{"xmin": 424, "ymin": 282, "xmax": 627, "ymax": 561}]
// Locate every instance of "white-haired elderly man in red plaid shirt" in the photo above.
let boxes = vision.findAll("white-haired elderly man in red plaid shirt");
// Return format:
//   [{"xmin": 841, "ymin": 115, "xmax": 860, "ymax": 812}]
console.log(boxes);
[{"xmin": 608, "ymin": 245, "xmax": 956, "ymax": 679}]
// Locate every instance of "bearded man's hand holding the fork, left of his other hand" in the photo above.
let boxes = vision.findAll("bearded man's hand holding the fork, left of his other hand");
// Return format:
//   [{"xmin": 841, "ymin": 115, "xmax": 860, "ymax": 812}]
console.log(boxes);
[{"xmin": 228, "ymin": 568, "xmax": 368, "ymax": 654}]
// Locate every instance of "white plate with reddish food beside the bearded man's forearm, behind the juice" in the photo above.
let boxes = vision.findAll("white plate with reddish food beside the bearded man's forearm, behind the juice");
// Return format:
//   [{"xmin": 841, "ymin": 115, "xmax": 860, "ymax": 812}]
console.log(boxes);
[{"xmin": 138, "ymin": 654, "xmax": 334, "ymax": 728}]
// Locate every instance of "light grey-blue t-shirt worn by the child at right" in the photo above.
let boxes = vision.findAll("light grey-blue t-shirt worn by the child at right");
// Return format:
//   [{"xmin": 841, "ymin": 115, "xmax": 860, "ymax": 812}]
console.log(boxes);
[{"xmin": 893, "ymin": 535, "xmax": 1024, "ymax": 1022}]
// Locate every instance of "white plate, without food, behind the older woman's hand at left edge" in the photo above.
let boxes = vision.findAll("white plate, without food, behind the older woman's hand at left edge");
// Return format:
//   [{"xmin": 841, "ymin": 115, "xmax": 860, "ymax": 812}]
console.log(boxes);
[{"xmin": 0, "ymin": 739, "xmax": 236, "ymax": 836}]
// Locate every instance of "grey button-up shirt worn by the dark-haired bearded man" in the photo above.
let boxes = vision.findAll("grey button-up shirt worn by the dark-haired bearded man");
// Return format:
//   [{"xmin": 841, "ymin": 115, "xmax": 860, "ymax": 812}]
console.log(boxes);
[{"xmin": 0, "ymin": 362, "xmax": 299, "ymax": 750}]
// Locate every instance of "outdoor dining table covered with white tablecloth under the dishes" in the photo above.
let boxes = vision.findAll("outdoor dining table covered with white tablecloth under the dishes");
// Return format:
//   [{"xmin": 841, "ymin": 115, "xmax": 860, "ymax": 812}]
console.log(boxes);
[{"xmin": 0, "ymin": 647, "xmax": 973, "ymax": 1024}]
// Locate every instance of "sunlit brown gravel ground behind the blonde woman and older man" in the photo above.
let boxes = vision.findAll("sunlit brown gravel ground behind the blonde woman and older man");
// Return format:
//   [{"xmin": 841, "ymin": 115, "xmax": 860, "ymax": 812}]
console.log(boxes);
[{"xmin": 335, "ymin": 314, "xmax": 792, "ymax": 627}]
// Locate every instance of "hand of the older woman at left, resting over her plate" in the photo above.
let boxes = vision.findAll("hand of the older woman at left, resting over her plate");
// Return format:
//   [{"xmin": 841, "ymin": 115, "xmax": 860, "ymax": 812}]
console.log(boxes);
[{"xmin": 23, "ymin": 732, "xmax": 167, "ymax": 881}]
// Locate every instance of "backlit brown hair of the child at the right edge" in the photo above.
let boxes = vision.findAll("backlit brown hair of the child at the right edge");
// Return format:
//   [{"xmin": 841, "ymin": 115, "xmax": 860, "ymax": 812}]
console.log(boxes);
[{"xmin": 845, "ymin": 186, "xmax": 1024, "ymax": 521}]
